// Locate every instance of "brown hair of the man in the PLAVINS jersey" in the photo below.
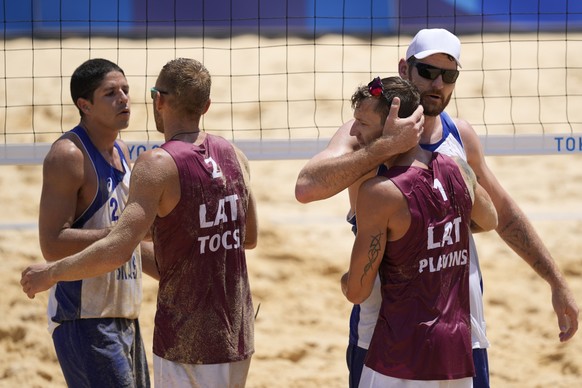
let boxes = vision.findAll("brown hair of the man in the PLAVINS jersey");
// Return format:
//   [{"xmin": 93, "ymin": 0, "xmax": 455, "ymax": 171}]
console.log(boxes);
[{"xmin": 351, "ymin": 77, "xmax": 420, "ymax": 125}]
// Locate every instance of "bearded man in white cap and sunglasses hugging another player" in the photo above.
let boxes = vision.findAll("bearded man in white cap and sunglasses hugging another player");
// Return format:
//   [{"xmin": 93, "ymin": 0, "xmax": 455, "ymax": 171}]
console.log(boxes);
[{"xmin": 295, "ymin": 28, "xmax": 579, "ymax": 387}]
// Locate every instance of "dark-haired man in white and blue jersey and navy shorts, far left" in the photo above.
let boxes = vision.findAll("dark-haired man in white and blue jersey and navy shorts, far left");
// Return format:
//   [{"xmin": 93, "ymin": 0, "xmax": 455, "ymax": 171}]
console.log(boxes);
[{"xmin": 33, "ymin": 59, "xmax": 157, "ymax": 387}]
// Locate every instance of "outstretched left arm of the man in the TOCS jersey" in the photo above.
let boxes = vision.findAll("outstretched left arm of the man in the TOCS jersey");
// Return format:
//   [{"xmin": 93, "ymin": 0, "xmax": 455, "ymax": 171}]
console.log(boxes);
[{"xmin": 21, "ymin": 149, "xmax": 171, "ymax": 298}]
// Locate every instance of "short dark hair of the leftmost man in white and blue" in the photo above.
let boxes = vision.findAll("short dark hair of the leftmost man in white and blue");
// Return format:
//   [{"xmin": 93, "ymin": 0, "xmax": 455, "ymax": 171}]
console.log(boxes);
[{"xmin": 71, "ymin": 58, "xmax": 125, "ymax": 115}]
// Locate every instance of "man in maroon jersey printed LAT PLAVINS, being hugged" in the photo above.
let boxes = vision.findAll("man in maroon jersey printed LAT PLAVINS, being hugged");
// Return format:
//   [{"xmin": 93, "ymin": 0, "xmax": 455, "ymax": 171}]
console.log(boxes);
[{"xmin": 342, "ymin": 77, "xmax": 497, "ymax": 387}]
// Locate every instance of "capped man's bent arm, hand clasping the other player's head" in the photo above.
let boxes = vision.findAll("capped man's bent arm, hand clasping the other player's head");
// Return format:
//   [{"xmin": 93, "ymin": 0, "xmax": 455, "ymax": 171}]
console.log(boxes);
[{"xmin": 295, "ymin": 98, "xmax": 424, "ymax": 203}]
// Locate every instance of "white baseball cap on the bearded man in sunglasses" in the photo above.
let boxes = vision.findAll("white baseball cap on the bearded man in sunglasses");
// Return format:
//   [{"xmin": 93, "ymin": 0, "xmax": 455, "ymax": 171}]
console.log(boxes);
[{"xmin": 406, "ymin": 28, "xmax": 461, "ymax": 67}]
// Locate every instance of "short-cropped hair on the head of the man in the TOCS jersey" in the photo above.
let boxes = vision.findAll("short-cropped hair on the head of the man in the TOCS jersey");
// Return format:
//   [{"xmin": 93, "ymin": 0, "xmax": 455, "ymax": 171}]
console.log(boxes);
[{"xmin": 156, "ymin": 58, "xmax": 212, "ymax": 116}]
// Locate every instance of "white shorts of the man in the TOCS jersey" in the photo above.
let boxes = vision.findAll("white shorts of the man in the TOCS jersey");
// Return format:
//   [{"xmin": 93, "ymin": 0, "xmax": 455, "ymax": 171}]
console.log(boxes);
[{"xmin": 154, "ymin": 354, "xmax": 251, "ymax": 388}]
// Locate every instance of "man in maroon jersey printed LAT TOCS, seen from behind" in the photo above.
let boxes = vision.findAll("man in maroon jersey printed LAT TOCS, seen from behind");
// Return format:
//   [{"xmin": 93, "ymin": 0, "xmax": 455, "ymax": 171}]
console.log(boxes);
[{"xmin": 21, "ymin": 58, "xmax": 258, "ymax": 387}]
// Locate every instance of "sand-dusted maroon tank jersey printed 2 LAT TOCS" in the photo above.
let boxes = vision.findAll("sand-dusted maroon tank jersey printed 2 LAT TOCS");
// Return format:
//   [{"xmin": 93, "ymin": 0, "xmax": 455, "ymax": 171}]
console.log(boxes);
[{"xmin": 153, "ymin": 134, "xmax": 254, "ymax": 364}]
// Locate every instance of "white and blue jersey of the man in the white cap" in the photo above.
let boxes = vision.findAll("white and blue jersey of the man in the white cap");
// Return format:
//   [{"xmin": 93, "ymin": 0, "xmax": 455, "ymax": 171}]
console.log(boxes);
[{"xmin": 348, "ymin": 112, "xmax": 489, "ymax": 349}]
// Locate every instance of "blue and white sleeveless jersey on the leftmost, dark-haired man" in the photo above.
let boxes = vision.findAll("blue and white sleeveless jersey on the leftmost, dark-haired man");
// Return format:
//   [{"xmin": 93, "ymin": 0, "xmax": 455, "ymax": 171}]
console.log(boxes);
[{"xmin": 47, "ymin": 126, "xmax": 142, "ymax": 334}]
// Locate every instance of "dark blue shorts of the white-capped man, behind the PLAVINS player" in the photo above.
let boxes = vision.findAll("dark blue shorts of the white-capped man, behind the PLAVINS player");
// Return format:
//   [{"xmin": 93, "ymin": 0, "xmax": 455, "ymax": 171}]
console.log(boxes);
[{"xmin": 346, "ymin": 344, "xmax": 489, "ymax": 388}]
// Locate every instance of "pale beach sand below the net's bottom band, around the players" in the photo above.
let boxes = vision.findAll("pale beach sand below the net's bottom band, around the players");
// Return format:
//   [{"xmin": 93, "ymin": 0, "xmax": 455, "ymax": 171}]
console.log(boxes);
[{"xmin": 0, "ymin": 155, "xmax": 582, "ymax": 388}]
